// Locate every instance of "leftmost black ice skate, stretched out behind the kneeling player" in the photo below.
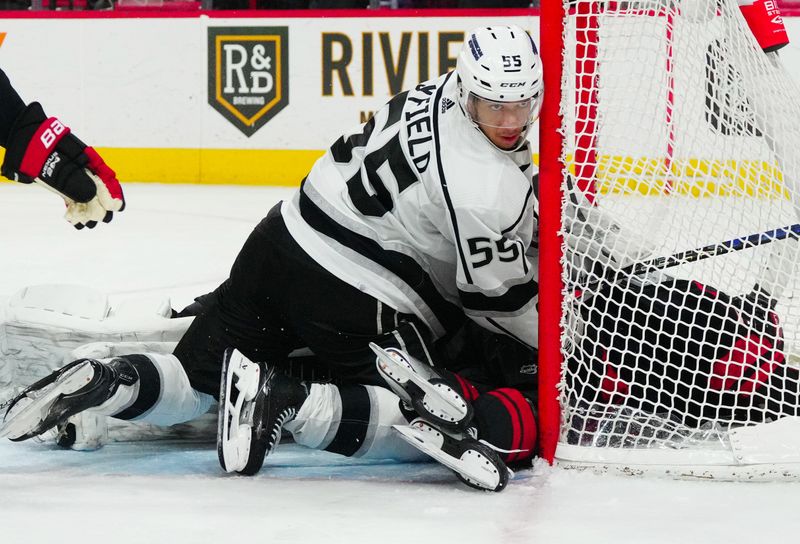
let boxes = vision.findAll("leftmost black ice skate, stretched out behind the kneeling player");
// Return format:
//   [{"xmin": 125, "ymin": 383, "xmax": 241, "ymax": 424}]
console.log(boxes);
[{"xmin": 0, "ymin": 359, "xmax": 133, "ymax": 442}]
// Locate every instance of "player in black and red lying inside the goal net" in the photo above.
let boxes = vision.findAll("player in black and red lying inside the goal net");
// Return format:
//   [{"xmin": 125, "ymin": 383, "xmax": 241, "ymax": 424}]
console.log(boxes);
[{"xmin": 564, "ymin": 164, "xmax": 800, "ymax": 445}]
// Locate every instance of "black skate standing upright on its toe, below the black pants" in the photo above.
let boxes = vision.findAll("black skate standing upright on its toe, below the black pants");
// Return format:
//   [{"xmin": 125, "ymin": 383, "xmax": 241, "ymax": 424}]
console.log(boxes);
[{"xmin": 217, "ymin": 350, "xmax": 308, "ymax": 475}]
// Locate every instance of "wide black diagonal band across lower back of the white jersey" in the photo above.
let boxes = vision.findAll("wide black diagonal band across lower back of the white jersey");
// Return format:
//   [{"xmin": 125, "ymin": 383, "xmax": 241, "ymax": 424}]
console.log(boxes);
[{"xmin": 300, "ymin": 189, "xmax": 464, "ymax": 331}]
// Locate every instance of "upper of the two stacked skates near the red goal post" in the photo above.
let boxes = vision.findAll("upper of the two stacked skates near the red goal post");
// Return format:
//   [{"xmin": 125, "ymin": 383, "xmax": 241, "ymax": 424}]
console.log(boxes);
[{"xmin": 369, "ymin": 343, "xmax": 472, "ymax": 431}]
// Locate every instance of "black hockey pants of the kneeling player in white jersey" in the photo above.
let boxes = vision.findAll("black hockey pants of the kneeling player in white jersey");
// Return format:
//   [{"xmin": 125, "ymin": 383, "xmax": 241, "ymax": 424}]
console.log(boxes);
[{"xmin": 174, "ymin": 204, "xmax": 435, "ymax": 396}]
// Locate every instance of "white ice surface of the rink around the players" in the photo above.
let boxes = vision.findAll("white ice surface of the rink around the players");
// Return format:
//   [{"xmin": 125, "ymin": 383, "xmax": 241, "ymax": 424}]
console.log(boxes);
[{"xmin": 0, "ymin": 184, "xmax": 800, "ymax": 544}]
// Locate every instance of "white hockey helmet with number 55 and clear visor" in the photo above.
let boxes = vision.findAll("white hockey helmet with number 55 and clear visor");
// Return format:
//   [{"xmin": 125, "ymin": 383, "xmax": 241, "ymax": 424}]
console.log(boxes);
[{"xmin": 456, "ymin": 25, "xmax": 544, "ymax": 152}]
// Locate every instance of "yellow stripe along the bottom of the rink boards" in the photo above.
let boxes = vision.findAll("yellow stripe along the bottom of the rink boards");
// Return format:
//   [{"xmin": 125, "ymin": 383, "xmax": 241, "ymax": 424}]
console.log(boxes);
[{"xmin": 0, "ymin": 147, "xmax": 789, "ymax": 198}]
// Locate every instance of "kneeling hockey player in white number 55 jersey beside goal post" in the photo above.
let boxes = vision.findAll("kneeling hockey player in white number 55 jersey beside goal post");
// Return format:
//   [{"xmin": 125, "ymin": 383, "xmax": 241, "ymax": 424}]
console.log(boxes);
[{"xmin": 0, "ymin": 26, "xmax": 542, "ymax": 491}]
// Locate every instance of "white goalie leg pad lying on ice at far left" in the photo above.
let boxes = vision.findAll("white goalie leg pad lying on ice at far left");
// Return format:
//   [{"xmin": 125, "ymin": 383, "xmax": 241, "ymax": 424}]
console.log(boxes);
[{"xmin": 0, "ymin": 285, "xmax": 191, "ymax": 403}]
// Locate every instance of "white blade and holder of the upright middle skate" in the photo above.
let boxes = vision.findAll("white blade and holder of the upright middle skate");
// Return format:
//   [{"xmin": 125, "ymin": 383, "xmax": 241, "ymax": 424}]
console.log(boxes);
[{"xmin": 217, "ymin": 350, "xmax": 261, "ymax": 472}]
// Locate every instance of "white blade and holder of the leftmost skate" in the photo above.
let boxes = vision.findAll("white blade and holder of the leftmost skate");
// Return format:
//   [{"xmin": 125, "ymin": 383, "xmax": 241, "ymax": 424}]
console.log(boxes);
[{"xmin": 0, "ymin": 361, "xmax": 94, "ymax": 440}]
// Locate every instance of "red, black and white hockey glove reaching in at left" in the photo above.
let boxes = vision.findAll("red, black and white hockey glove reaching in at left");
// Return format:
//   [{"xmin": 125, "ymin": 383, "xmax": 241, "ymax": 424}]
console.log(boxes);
[{"xmin": 0, "ymin": 102, "xmax": 125, "ymax": 229}]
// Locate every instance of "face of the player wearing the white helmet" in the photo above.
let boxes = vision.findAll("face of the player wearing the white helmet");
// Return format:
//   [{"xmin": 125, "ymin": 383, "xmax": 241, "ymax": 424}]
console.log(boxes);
[{"xmin": 470, "ymin": 96, "xmax": 534, "ymax": 149}]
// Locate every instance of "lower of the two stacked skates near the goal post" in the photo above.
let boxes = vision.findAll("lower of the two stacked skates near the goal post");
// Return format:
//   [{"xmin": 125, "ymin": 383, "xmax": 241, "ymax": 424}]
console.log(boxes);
[{"xmin": 393, "ymin": 418, "xmax": 514, "ymax": 491}]
